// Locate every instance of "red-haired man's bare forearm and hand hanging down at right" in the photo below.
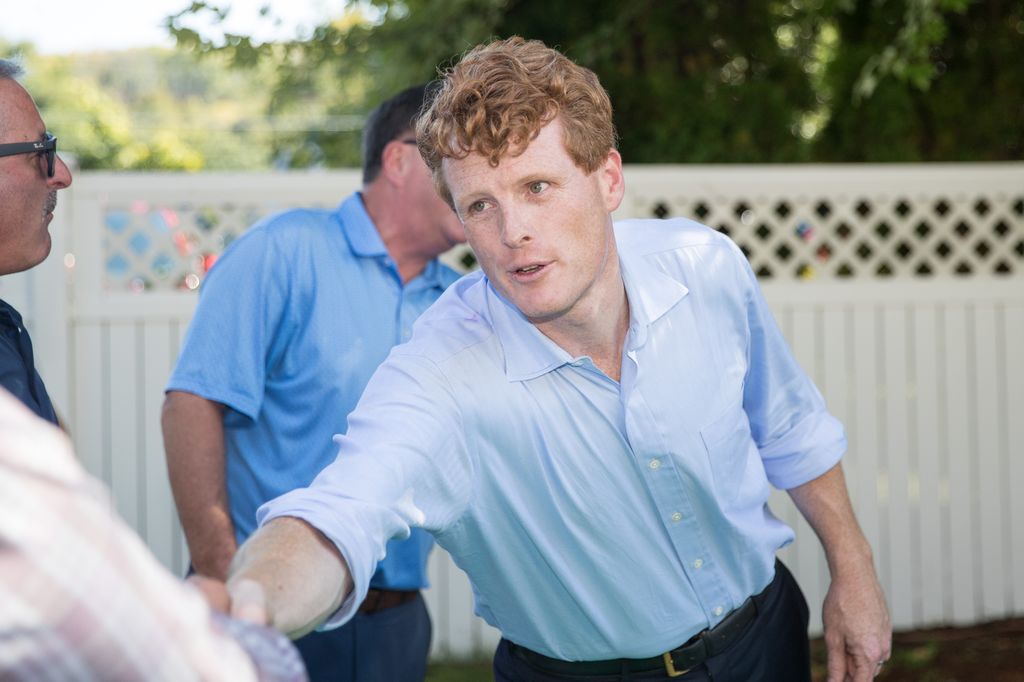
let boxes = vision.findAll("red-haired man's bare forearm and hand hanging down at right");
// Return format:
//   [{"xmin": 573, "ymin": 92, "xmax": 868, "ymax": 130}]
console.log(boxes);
[{"xmin": 790, "ymin": 464, "xmax": 892, "ymax": 682}]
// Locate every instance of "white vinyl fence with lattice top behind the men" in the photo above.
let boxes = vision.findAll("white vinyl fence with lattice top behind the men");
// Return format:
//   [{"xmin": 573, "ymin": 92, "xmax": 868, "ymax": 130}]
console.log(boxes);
[{"xmin": 0, "ymin": 164, "xmax": 1024, "ymax": 656}]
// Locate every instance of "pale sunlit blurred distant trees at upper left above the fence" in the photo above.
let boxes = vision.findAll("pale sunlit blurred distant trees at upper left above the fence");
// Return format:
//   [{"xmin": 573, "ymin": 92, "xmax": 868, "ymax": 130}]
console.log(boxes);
[{"xmin": 0, "ymin": 44, "xmax": 272, "ymax": 171}]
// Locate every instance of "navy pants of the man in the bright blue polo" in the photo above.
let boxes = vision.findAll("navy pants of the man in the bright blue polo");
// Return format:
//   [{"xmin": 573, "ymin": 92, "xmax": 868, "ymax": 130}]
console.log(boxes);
[{"xmin": 295, "ymin": 595, "xmax": 430, "ymax": 682}]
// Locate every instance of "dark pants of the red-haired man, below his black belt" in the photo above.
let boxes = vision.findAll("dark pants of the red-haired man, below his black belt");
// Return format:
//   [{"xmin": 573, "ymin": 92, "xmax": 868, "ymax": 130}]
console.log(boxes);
[{"xmin": 494, "ymin": 561, "xmax": 811, "ymax": 682}]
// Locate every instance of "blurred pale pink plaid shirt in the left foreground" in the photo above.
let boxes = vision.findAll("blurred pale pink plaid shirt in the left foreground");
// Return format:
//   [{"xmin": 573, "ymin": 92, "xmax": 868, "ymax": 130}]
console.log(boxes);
[{"xmin": 0, "ymin": 389, "xmax": 305, "ymax": 682}]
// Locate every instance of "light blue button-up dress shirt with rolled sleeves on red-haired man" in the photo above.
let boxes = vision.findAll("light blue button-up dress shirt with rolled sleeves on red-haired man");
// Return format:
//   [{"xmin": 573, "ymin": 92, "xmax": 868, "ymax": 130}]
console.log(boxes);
[{"xmin": 259, "ymin": 215, "xmax": 846, "ymax": 660}]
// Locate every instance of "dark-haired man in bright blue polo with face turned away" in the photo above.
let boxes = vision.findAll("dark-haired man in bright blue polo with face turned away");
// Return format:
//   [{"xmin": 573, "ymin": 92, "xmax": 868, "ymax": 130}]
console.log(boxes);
[{"xmin": 163, "ymin": 86, "xmax": 464, "ymax": 682}]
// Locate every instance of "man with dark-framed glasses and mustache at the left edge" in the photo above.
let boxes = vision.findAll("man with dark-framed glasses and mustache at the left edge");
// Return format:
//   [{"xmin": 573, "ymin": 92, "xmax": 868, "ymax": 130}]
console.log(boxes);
[{"xmin": 0, "ymin": 59, "xmax": 71, "ymax": 424}]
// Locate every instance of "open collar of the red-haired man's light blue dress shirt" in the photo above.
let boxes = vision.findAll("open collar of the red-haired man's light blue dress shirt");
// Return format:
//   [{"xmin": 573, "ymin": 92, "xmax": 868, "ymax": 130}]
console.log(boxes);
[{"xmin": 484, "ymin": 245, "xmax": 689, "ymax": 381}]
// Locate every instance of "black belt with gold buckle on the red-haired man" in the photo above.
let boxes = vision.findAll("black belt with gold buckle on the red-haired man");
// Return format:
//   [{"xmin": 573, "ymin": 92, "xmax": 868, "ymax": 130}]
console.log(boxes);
[{"xmin": 509, "ymin": 566, "xmax": 779, "ymax": 677}]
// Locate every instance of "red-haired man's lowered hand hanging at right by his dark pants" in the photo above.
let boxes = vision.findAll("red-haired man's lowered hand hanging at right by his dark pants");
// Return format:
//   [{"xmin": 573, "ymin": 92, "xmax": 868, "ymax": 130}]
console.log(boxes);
[{"xmin": 822, "ymin": 566, "xmax": 892, "ymax": 682}]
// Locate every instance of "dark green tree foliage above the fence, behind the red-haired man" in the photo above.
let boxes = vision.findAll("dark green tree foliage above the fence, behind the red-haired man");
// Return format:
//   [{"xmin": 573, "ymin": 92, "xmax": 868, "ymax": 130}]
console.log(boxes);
[{"xmin": 168, "ymin": 0, "xmax": 1024, "ymax": 165}]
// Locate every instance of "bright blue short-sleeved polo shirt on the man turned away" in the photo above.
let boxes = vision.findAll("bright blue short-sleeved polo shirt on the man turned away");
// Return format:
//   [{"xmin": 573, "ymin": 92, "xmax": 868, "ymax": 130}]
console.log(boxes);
[{"xmin": 167, "ymin": 194, "xmax": 458, "ymax": 590}]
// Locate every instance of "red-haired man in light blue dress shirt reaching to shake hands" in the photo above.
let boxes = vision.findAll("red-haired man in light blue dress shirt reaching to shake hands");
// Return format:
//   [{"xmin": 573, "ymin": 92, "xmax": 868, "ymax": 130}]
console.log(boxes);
[{"xmin": 207, "ymin": 38, "xmax": 891, "ymax": 682}]
